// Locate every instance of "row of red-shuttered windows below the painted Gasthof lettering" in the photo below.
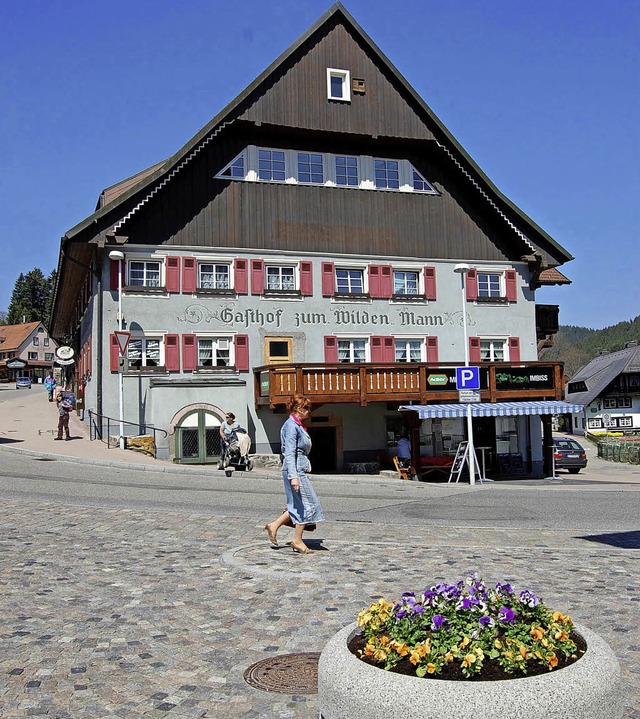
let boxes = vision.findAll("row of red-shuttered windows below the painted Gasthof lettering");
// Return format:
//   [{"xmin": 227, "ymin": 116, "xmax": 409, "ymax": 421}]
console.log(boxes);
[{"xmin": 110, "ymin": 334, "xmax": 520, "ymax": 372}]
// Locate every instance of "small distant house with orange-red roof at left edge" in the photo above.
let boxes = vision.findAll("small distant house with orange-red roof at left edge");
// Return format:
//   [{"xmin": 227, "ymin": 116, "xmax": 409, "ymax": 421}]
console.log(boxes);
[{"xmin": 0, "ymin": 322, "xmax": 58, "ymax": 382}]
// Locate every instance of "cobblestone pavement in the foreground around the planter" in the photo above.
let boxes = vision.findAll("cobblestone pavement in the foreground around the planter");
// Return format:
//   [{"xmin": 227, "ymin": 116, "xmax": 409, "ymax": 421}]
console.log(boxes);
[{"xmin": 0, "ymin": 501, "xmax": 640, "ymax": 719}]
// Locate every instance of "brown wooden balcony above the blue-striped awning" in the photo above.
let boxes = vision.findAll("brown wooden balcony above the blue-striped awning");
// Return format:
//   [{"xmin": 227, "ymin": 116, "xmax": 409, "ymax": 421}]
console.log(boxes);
[{"xmin": 254, "ymin": 362, "xmax": 564, "ymax": 409}]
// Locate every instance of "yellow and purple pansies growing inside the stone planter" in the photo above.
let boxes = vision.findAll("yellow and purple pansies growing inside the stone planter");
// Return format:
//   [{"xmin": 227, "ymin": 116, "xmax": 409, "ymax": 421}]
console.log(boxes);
[{"xmin": 350, "ymin": 574, "xmax": 586, "ymax": 680}]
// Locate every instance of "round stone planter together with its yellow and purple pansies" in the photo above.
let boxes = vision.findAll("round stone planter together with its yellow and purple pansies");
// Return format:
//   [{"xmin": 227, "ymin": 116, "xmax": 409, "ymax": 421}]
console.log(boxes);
[{"xmin": 318, "ymin": 575, "xmax": 624, "ymax": 719}]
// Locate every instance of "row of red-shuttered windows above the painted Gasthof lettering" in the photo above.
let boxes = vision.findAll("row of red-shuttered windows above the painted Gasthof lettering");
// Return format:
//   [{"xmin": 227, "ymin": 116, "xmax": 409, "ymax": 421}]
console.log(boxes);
[{"xmin": 111, "ymin": 257, "xmax": 517, "ymax": 302}]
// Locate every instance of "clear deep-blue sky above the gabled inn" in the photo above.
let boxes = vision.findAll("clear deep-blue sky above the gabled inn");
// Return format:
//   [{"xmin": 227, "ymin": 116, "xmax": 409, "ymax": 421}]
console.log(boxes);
[{"xmin": 0, "ymin": 0, "xmax": 640, "ymax": 328}]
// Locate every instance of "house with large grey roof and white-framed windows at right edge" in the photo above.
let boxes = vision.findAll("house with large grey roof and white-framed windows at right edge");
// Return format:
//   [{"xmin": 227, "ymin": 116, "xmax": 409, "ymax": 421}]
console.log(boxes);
[{"xmin": 567, "ymin": 341, "xmax": 640, "ymax": 434}]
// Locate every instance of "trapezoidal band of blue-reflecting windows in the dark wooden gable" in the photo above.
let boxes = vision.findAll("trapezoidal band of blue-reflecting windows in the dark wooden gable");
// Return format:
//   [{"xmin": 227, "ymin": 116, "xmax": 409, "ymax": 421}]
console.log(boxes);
[{"xmin": 216, "ymin": 145, "xmax": 438, "ymax": 195}]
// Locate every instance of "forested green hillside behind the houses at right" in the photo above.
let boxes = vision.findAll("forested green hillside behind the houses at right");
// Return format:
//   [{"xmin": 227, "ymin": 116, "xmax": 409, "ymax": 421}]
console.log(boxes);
[{"xmin": 540, "ymin": 315, "xmax": 640, "ymax": 377}]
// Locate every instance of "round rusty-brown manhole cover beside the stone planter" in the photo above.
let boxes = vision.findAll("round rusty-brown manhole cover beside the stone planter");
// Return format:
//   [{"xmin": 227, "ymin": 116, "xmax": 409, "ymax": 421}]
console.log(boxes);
[{"xmin": 244, "ymin": 652, "xmax": 320, "ymax": 694}]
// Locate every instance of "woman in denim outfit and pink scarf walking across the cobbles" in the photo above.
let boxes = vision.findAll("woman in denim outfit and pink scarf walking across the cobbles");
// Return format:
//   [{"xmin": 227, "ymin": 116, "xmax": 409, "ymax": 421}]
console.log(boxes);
[{"xmin": 264, "ymin": 394, "xmax": 324, "ymax": 554}]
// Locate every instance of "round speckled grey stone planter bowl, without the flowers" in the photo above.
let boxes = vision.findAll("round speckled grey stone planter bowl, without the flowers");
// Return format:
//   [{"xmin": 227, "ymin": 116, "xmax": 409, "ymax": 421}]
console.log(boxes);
[{"xmin": 318, "ymin": 623, "xmax": 623, "ymax": 719}]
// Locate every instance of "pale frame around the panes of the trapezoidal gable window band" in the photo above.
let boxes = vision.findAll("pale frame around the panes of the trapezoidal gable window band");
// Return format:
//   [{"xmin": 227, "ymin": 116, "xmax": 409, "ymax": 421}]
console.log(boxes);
[{"xmin": 215, "ymin": 145, "xmax": 439, "ymax": 195}]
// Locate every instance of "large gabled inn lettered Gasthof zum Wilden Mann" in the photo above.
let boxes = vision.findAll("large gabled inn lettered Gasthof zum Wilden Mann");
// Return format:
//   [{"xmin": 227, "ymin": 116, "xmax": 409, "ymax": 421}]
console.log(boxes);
[{"xmin": 52, "ymin": 3, "xmax": 572, "ymax": 476}]
